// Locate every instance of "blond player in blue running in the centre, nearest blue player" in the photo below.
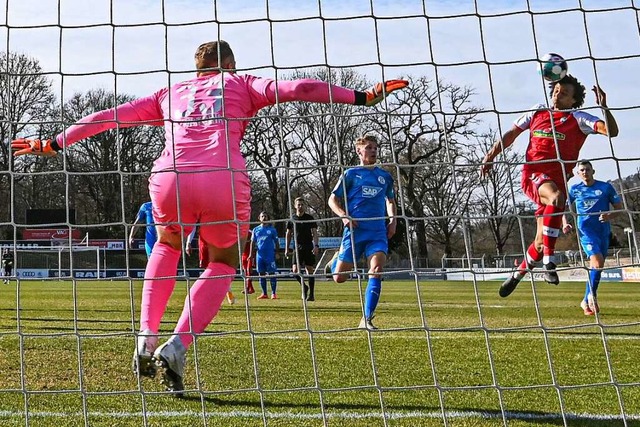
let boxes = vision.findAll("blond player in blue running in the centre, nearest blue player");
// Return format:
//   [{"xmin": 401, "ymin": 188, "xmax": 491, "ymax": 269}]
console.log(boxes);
[{"xmin": 329, "ymin": 135, "xmax": 397, "ymax": 329}]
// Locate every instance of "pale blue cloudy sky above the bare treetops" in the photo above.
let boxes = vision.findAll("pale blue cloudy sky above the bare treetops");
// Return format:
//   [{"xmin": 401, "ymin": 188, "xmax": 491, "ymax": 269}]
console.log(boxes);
[{"xmin": 0, "ymin": 0, "xmax": 640, "ymax": 179}]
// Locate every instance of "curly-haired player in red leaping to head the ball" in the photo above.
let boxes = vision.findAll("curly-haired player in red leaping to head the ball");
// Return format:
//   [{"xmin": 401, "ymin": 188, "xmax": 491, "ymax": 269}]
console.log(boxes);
[{"xmin": 480, "ymin": 75, "xmax": 618, "ymax": 297}]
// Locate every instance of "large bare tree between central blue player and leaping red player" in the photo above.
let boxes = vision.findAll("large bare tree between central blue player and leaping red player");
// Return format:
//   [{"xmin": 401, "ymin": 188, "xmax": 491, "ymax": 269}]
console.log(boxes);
[{"xmin": 370, "ymin": 77, "xmax": 479, "ymax": 257}]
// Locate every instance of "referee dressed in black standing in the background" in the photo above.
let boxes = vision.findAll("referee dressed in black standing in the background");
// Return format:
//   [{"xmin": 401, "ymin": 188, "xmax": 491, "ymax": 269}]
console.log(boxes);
[{"xmin": 284, "ymin": 197, "xmax": 320, "ymax": 301}]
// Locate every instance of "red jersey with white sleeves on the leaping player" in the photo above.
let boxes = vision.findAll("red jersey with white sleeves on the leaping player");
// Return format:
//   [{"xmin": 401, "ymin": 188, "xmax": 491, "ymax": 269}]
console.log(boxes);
[{"xmin": 514, "ymin": 104, "xmax": 602, "ymax": 181}]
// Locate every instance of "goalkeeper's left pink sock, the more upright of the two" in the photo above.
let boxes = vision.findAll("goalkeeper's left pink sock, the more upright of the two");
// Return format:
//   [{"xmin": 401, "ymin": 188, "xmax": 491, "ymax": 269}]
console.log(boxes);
[{"xmin": 140, "ymin": 242, "xmax": 181, "ymax": 333}]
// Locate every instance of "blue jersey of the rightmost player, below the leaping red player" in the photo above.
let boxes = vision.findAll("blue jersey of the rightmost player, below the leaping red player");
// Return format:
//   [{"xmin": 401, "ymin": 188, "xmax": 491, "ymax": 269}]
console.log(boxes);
[{"xmin": 569, "ymin": 180, "xmax": 620, "ymax": 238}]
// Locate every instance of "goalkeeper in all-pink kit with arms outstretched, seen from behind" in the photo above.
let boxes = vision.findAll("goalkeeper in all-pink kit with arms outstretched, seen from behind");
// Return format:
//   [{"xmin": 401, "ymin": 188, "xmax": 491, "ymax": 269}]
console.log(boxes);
[{"xmin": 11, "ymin": 40, "xmax": 408, "ymax": 396}]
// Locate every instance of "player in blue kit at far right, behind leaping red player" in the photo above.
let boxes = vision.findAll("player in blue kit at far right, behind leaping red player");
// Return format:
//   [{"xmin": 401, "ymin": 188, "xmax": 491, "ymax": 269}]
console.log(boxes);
[{"xmin": 565, "ymin": 160, "xmax": 622, "ymax": 316}]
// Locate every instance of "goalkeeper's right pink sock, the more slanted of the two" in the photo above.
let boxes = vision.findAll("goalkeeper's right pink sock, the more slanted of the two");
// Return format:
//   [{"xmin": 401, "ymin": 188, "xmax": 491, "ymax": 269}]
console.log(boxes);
[{"xmin": 174, "ymin": 262, "xmax": 236, "ymax": 348}]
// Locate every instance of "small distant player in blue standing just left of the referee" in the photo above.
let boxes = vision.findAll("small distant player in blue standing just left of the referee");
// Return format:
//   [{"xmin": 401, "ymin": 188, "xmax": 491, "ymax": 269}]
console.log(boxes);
[{"xmin": 250, "ymin": 211, "xmax": 280, "ymax": 299}]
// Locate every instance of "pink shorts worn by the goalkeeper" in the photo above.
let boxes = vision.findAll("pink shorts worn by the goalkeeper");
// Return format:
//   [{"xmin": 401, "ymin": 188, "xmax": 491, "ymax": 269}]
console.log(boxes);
[{"xmin": 149, "ymin": 169, "xmax": 251, "ymax": 248}]
